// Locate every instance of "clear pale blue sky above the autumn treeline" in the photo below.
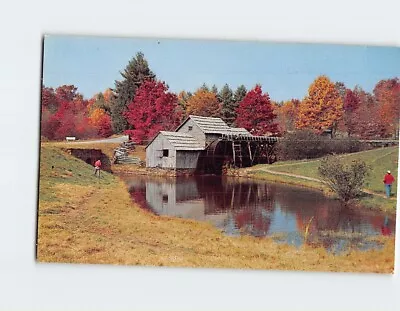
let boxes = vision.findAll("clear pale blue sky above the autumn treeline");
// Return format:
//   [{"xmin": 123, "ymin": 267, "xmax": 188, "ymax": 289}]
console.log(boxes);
[{"xmin": 43, "ymin": 35, "xmax": 400, "ymax": 101}]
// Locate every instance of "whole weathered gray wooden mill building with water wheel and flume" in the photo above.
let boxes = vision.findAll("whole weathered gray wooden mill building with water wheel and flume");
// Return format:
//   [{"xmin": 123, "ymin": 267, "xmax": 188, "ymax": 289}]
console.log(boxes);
[{"xmin": 146, "ymin": 115, "xmax": 277, "ymax": 173}]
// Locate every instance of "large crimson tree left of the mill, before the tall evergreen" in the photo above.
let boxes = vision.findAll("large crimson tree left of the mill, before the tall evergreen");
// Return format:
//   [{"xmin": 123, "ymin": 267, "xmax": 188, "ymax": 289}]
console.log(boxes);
[{"xmin": 124, "ymin": 80, "xmax": 181, "ymax": 143}]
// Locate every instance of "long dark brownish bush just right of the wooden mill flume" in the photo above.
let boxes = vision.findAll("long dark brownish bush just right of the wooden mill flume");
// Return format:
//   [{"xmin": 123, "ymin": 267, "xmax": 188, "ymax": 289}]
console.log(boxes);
[{"xmin": 277, "ymin": 130, "xmax": 366, "ymax": 160}]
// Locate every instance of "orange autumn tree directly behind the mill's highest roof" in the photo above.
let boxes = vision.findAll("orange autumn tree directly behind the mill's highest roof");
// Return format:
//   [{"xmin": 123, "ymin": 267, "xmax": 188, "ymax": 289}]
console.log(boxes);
[{"xmin": 186, "ymin": 88, "xmax": 221, "ymax": 117}]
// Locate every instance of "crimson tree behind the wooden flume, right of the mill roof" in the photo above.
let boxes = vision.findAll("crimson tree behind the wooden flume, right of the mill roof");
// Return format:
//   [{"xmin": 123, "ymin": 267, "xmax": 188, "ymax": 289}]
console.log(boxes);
[{"xmin": 236, "ymin": 85, "xmax": 278, "ymax": 135}]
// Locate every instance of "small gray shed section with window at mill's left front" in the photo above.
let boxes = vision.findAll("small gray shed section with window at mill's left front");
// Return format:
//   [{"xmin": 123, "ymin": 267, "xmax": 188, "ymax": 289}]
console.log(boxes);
[{"xmin": 146, "ymin": 131, "xmax": 204, "ymax": 169}]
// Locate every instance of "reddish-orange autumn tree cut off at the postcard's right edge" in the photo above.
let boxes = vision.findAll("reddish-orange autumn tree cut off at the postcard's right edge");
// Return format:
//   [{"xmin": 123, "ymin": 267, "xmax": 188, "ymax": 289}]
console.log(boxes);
[{"xmin": 374, "ymin": 78, "xmax": 400, "ymax": 137}]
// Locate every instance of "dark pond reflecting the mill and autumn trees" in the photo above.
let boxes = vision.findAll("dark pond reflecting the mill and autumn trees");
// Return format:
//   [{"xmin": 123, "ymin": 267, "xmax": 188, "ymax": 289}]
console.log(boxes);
[{"xmin": 123, "ymin": 176, "xmax": 395, "ymax": 254}]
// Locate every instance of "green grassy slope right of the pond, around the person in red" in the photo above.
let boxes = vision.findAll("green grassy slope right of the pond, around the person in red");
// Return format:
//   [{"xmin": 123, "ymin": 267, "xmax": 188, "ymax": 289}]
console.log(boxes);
[{"xmin": 247, "ymin": 147, "xmax": 399, "ymax": 210}]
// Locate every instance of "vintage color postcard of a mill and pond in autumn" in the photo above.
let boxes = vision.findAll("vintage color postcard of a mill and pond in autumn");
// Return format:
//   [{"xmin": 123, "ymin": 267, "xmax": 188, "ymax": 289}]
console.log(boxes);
[{"xmin": 37, "ymin": 35, "xmax": 400, "ymax": 273}]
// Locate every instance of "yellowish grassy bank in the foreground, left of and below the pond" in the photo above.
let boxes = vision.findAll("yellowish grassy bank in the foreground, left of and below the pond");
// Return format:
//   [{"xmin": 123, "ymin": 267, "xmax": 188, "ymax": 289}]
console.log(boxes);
[{"xmin": 37, "ymin": 144, "xmax": 394, "ymax": 273}]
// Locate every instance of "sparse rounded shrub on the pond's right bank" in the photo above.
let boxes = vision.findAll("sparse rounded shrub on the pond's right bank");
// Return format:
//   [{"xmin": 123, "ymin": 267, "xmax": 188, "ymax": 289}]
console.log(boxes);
[{"xmin": 318, "ymin": 156, "xmax": 369, "ymax": 203}]
